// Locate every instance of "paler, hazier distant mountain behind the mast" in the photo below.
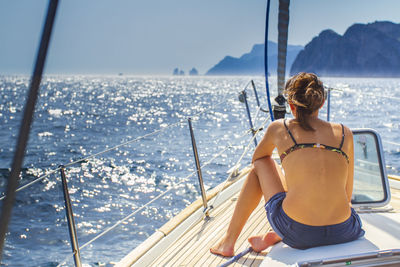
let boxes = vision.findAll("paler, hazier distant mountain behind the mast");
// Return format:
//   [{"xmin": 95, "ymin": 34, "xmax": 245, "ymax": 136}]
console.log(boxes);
[{"xmin": 206, "ymin": 41, "xmax": 303, "ymax": 75}]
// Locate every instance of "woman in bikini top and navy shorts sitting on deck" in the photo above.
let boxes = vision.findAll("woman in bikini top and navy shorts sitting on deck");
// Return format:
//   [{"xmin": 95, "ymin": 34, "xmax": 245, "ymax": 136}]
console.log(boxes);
[{"xmin": 210, "ymin": 73, "xmax": 364, "ymax": 256}]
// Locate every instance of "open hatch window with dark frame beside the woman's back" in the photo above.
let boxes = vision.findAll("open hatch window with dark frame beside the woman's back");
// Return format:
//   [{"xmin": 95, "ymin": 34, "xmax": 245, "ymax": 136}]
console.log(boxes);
[{"xmin": 352, "ymin": 129, "xmax": 390, "ymax": 206}]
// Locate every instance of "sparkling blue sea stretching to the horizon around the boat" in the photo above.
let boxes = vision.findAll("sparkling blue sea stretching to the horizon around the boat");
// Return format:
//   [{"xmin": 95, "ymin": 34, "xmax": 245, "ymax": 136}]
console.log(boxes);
[{"xmin": 0, "ymin": 75, "xmax": 400, "ymax": 266}]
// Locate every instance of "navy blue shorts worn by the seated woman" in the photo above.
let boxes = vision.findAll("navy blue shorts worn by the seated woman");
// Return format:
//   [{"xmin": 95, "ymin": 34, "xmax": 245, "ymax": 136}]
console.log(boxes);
[{"xmin": 265, "ymin": 192, "xmax": 365, "ymax": 249}]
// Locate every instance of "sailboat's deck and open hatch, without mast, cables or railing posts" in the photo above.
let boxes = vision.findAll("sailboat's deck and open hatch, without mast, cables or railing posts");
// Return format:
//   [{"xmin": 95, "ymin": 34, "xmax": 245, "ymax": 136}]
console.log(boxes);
[{"xmin": 116, "ymin": 133, "xmax": 400, "ymax": 266}]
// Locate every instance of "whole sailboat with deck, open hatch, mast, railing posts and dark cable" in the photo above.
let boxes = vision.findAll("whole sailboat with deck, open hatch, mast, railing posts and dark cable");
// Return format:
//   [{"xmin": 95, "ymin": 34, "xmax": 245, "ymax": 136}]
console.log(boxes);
[{"xmin": 0, "ymin": 1, "xmax": 400, "ymax": 266}]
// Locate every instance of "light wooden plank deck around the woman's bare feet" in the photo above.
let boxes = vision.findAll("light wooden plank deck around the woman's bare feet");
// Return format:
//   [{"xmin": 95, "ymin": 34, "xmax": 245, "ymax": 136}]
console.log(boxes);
[{"xmin": 151, "ymin": 188, "xmax": 400, "ymax": 266}]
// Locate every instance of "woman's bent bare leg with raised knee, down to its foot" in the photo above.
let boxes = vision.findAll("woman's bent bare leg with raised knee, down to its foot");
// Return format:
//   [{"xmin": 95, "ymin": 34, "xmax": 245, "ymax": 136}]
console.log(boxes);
[{"xmin": 210, "ymin": 157, "xmax": 284, "ymax": 256}]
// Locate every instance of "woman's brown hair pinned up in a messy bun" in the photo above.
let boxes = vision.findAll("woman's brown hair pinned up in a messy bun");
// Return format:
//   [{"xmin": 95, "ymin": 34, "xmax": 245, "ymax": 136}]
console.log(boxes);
[{"xmin": 284, "ymin": 72, "xmax": 325, "ymax": 131}]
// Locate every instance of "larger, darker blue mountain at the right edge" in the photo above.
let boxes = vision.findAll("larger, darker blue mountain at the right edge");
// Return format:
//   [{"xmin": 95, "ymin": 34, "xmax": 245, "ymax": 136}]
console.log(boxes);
[{"xmin": 290, "ymin": 21, "xmax": 400, "ymax": 77}]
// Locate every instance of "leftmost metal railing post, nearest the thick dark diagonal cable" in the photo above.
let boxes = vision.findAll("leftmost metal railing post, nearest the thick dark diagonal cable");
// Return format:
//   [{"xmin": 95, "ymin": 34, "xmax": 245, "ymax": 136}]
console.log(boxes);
[{"xmin": 60, "ymin": 165, "xmax": 82, "ymax": 267}]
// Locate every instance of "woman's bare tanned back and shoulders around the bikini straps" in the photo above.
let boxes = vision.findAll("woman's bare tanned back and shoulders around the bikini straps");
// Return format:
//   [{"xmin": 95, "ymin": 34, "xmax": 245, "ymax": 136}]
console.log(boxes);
[{"xmin": 256, "ymin": 119, "xmax": 353, "ymax": 225}]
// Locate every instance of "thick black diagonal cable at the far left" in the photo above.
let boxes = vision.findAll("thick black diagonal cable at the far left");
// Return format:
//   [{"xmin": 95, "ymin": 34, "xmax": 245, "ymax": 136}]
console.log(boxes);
[{"xmin": 0, "ymin": 0, "xmax": 58, "ymax": 262}]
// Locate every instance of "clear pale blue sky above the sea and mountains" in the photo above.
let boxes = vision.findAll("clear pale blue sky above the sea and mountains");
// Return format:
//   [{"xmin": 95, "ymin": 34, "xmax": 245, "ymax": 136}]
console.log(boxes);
[{"xmin": 0, "ymin": 0, "xmax": 400, "ymax": 75}]
